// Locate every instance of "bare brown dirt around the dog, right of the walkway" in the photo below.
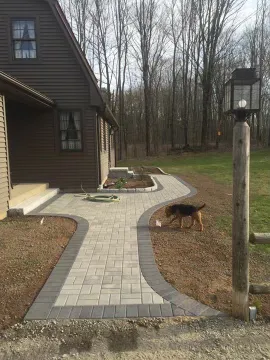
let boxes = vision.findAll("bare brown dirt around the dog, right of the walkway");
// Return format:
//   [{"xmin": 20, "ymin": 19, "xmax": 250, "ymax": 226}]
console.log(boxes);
[{"xmin": 150, "ymin": 174, "xmax": 270, "ymax": 316}]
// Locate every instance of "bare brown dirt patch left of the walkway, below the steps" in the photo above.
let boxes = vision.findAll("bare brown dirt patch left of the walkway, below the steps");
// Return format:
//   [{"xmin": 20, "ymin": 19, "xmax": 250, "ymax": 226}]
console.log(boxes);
[{"xmin": 0, "ymin": 216, "xmax": 77, "ymax": 329}]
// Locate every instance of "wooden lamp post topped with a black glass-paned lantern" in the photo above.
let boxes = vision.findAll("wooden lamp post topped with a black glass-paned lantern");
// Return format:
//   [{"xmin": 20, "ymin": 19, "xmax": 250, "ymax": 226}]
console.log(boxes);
[{"xmin": 224, "ymin": 68, "xmax": 260, "ymax": 321}]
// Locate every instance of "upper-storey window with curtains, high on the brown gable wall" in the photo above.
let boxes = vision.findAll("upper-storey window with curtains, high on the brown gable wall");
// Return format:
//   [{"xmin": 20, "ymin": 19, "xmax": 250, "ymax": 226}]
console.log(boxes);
[{"xmin": 12, "ymin": 20, "xmax": 37, "ymax": 59}]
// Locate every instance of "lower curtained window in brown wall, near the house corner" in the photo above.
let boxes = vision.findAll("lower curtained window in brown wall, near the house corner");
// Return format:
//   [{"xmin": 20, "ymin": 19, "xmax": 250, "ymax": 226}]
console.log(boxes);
[{"xmin": 59, "ymin": 110, "xmax": 82, "ymax": 151}]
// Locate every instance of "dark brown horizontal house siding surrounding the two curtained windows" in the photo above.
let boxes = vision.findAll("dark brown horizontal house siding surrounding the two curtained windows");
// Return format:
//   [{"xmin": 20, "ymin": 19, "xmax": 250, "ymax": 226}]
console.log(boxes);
[{"xmin": 0, "ymin": 0, "xmax": 98, "ymax": 189}]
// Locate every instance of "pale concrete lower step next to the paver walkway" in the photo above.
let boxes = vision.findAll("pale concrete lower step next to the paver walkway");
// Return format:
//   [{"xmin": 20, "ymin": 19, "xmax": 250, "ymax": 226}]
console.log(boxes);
[{"xmin": 8, "ymin": 189, "xmax": 59, "ymax": 216}]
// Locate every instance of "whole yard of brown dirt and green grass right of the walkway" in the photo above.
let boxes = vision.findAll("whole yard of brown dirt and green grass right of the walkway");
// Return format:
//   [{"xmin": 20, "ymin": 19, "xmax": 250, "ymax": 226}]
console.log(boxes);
[{"xmin": 119, "ymin": 149, "xmax": 270, "ymax": 317}]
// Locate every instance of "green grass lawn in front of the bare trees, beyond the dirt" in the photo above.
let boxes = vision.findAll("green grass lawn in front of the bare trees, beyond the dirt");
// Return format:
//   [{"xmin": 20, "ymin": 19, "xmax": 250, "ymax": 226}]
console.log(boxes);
[{"xmin": 118, "ymin": 149, "xmax": 270, "ymax": 252}]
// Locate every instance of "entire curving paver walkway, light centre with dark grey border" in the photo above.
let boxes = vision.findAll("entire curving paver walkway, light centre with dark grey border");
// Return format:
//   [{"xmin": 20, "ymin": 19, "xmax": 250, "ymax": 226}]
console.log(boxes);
[{"xmin": 26, "ymin": 175, "xmax": 224, "ymax": 319}]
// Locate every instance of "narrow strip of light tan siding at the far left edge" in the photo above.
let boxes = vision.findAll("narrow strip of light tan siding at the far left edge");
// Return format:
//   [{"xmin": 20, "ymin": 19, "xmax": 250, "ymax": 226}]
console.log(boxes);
[{"xmin": 0, "ymin": 94, "xmax": 9, "ymax": 220}]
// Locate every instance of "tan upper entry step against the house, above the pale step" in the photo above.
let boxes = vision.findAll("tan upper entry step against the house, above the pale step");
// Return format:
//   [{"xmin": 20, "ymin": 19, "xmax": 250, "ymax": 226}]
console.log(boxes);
[{"xmin": 9, "ymin": 183, "xmax": 49, "ymax": 208}]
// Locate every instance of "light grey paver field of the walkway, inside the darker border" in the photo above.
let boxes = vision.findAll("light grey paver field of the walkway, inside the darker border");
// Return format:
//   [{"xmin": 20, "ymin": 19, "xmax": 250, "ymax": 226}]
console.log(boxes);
[{"xmin": 42, "ymin": 175, "xmax": 190, "ymax": 306}]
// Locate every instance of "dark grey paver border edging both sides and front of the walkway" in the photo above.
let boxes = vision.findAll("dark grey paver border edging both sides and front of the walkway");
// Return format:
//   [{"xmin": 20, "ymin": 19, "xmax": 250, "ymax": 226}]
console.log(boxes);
[{"xmin": 24, "ymin": 175, "xmax": 224, "ymax": 320}]
